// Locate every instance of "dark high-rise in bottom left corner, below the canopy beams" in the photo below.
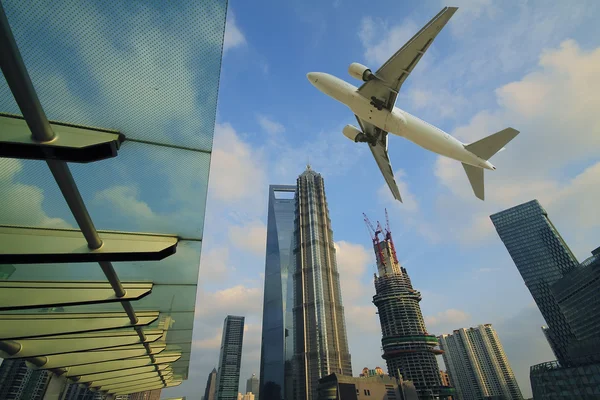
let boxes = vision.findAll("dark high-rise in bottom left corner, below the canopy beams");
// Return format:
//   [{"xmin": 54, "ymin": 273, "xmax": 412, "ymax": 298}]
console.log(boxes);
[{"xmin": 0, "ymin": 359, "xmax": 50, "ymax": 400}]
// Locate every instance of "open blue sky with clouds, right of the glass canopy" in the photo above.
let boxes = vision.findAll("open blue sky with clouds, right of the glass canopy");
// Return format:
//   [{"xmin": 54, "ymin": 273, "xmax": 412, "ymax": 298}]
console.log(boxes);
[{"xmin": 182, "ymin": 0, "xmax": 600, "ymax": 396}]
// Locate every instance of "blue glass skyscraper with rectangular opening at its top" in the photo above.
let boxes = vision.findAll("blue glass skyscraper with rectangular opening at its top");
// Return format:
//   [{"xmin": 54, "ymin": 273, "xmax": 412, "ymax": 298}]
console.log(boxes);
[{"xmin": 252, "ymin": 185, "xmax": 296, "ymax": 400}]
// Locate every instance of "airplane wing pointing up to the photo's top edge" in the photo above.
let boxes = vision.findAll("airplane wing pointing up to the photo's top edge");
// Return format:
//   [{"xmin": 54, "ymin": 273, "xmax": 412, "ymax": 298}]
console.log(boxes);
[{"xmin": 358, "ymin": 7, "xmax": 458, "ymax": 111}]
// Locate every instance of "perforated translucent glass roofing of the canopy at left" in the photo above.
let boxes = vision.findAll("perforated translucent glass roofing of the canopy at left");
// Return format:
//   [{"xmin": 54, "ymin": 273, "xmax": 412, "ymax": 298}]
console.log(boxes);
[{"xmin": 0, "ymin": 0, "xmax": 227, "ymax": 390}]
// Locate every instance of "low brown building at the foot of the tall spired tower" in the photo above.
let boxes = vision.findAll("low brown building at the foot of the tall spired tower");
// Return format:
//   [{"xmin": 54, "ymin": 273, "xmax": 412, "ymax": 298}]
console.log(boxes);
[{"xmin": 316, "ymin": 374, "xmax": 419, "ymax": 400}]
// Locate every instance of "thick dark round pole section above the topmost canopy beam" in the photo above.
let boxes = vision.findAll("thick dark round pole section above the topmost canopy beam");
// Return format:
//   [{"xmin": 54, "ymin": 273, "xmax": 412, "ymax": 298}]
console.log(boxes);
[{"xmin": 0, "ymin": 3, "xmax": 55, "ymax": 142}]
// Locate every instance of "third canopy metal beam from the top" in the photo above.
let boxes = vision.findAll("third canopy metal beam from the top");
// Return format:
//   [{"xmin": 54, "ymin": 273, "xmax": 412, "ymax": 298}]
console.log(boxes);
[{"xmin": 0, "ymin": 281, "xmax": 152, "ymax": 311}]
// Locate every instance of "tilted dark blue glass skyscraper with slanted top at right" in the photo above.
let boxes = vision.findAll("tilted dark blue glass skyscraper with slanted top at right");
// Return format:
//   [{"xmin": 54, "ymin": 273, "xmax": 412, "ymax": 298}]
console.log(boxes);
[{"xmin": 490, "ymin": 200, "xmax": 579, "ymax": 365}]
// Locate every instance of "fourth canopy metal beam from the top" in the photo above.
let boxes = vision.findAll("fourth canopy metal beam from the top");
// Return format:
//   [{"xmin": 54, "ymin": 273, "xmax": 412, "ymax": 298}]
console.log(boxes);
[{"xmin": 0, "ymin": 311, "xmax": 159, "ymax": 340}]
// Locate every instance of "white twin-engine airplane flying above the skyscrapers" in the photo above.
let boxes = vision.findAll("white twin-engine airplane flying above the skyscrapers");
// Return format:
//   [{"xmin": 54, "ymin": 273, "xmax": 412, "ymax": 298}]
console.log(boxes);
[{"xmin": 307, "ymin": 7, "xmax": 519, "ymax": 202}]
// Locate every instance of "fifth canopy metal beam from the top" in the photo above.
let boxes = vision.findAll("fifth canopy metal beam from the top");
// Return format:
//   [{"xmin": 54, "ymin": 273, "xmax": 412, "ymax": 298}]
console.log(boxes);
[{"xmin": 0, "ymin": 330, "xmax": 164, "ymax": 358}]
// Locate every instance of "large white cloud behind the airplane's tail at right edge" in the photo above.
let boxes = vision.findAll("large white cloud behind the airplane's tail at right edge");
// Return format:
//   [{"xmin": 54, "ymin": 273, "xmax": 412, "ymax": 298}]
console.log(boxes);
[{"xmin": 435, "ymin": 40, "xmax": 600, "ymax": 246}]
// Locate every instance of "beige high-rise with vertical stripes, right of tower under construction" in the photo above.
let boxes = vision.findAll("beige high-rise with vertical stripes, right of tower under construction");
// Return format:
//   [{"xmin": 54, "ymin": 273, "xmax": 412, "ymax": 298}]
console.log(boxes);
[{"xmin": 439, "ymin": 324, "xmax": 523, "ymax": 400}]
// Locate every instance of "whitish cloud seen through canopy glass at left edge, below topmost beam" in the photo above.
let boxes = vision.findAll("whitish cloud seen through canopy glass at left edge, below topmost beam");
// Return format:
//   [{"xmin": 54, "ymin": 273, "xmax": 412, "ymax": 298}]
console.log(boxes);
[{"xmin": 0, "ymin": 158, "xmax": 72, "ymax": 228}]
